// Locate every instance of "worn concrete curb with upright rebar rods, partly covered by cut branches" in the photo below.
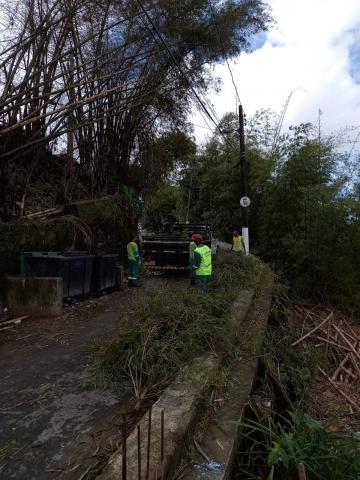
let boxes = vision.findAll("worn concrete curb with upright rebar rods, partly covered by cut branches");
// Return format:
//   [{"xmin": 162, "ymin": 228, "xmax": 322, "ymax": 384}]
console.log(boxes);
[{"xmin": 97, "ymin": 284, "xmax": 255, "ymax": 480}]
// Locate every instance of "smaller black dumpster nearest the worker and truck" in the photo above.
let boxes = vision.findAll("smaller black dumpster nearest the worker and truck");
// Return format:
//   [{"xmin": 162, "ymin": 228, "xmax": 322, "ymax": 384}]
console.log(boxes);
[{"xmin": 91, "ymin": 254, "xmax": 118, "ymax": 295}]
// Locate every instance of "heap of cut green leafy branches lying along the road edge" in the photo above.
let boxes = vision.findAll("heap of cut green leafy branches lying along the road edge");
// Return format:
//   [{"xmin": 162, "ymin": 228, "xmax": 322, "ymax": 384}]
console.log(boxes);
[{"xmin": 91, "ymin": 252, "xmax": 263, "ymax": 401}]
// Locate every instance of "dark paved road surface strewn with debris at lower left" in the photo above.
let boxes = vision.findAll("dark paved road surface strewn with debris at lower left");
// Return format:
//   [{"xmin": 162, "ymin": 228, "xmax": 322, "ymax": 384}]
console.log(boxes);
[{"xmin": 0, "ymin": 289, "xmax": 141, "ymax": 480}]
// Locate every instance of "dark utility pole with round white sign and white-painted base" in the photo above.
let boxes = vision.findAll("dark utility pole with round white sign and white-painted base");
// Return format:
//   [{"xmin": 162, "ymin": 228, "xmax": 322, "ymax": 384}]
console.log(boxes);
[{"xmin": 239, "ymin": 105, "xmax": 250, "ymax": 255}]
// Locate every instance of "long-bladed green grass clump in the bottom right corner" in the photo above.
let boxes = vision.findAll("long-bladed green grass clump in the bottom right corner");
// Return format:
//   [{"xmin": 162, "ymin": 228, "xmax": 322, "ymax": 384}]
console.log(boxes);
[{"xmin": 234, "ymin": 413, "xmax": 360, "ymax": 480}]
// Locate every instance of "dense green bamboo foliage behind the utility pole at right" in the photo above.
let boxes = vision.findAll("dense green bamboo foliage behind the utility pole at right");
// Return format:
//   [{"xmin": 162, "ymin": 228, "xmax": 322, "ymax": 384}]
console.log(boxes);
[{"xmin": 183, "ymin": 111, "xmax": 360, "ymax": 310}]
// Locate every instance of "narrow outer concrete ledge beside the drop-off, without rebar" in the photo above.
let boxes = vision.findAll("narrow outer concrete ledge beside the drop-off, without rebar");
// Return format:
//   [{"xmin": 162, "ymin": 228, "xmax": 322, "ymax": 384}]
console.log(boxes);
[{"xmin": 182, "ymin": 270, "xmax": 274, "ymax": 480}]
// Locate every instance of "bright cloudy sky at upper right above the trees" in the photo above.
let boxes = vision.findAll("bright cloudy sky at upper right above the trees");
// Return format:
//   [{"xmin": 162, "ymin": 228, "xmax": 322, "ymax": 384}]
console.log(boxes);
[{"xmin": 192, "ymin": 0, "xmax": 360, "ymax": 149}]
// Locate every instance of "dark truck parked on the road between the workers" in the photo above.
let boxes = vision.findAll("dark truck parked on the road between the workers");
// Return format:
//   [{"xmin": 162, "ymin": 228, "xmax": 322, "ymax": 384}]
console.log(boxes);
[{"xmin": 141, "ymin": 223, "xmax": 218, "ymax": 271}]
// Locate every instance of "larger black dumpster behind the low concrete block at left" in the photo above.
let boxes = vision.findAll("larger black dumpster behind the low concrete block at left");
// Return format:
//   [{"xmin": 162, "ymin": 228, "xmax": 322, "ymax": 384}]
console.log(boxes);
[{"xmin": 26, "ymin": 252, "xmax": 94, "ymax": 297}]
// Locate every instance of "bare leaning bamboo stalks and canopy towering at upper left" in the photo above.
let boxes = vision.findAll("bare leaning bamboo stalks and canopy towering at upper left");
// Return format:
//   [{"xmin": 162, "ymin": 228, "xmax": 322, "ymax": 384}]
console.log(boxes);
[{"xmin": 0, "ymin": 0, "xmax": 270, "ymax": 219}]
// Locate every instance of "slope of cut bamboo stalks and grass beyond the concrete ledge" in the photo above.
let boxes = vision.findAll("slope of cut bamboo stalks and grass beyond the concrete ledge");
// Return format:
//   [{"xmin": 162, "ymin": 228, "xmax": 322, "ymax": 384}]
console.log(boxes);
[{"xmin": 233, "ymin": 296, "xmax": 360, "ymax": 480}]
